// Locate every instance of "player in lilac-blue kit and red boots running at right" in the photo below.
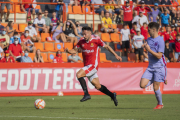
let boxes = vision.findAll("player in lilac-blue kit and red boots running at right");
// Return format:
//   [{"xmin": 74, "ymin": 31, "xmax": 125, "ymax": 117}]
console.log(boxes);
[{"xmin": 140, "ymin": 22, "xmax": 167, "ymax": 109}]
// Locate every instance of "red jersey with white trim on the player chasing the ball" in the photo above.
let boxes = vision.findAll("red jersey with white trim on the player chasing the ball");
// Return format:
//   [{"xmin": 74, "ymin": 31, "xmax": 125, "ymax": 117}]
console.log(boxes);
[{"xmin": 76, "ymin": 38, "xmax": 105, "ymax": 69}]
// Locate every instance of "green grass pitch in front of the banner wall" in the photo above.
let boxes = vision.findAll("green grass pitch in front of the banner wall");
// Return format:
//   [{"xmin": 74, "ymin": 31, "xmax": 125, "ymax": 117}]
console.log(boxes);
[{"xmin": 0, "ymin": 94, "xmax": 180, "ymax": 120}]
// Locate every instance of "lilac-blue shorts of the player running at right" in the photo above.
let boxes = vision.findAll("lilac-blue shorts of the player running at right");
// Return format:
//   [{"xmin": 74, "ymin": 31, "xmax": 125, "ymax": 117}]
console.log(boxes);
[{"xmin": 142, "ymin": 66, "xmax": 167, "ymax": 82}]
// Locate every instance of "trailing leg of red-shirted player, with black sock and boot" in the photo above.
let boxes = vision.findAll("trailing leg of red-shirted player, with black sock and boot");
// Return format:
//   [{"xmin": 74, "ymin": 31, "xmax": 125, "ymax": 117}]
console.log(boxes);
[{"xmin": 88, "ymin": 73, "xmax": 118, "ymax": 106}]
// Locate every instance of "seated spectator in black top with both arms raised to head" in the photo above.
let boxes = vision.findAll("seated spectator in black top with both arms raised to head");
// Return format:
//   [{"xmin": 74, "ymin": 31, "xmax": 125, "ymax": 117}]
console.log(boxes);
[{"xmin": 63, "ymin": 20, "xmax": 81, "ymax": 43}]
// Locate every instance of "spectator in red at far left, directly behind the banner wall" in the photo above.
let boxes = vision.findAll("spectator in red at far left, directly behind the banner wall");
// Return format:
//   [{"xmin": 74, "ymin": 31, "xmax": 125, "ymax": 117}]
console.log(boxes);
[{"xmin": 0, "ymin": 50, "xmax": 15, "ymax": 63}]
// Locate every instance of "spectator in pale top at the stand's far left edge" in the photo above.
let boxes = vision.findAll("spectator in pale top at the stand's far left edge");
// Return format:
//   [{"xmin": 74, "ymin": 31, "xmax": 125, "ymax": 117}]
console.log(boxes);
[{"xmin": 0, "ymin": 28, "xmax": 9, "ymax": 51}]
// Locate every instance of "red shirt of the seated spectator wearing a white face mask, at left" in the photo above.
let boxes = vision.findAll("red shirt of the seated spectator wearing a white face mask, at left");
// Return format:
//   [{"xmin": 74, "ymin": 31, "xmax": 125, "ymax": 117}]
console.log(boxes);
[{"xmin": 9, "ymin": 43, "xmax": 22, "ymax": 56}]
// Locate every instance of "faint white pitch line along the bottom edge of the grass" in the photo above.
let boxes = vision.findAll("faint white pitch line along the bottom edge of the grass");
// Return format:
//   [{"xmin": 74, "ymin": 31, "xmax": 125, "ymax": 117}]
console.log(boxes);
[{"xmin": 0, "ymin": 116, "xmax": 134, "ymax": 120}]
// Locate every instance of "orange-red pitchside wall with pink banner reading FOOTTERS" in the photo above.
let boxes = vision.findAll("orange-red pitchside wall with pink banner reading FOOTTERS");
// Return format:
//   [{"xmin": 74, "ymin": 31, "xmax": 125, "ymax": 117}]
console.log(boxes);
[{"xmin": 0, "ymin": 63, "xmax": 180, "ymax": 96}]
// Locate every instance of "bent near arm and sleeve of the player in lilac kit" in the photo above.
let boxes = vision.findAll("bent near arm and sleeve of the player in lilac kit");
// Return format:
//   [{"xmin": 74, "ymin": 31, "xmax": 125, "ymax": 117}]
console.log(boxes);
[{"xmin": 144, "ymin": 40, "xmax": 165, "ymax": 59}]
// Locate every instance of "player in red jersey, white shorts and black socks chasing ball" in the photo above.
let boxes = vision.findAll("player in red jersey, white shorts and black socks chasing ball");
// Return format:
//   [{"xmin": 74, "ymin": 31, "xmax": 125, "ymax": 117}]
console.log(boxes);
[{"xmin": 66, "ymin": 27, "xmax": 122, "ymax": 106}]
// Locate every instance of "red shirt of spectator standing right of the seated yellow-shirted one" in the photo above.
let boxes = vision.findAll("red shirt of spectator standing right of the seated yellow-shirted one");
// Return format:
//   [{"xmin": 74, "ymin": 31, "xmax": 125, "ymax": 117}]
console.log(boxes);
[{"xmin": 123, "ymin": 6, "xmax": 133, "ymax": 21}]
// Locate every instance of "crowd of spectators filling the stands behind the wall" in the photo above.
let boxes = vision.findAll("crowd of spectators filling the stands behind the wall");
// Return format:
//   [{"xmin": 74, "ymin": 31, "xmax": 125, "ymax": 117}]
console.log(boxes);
[{"xmin": 0, "ymin": 0, "xmax": 180, "ymax": 63}]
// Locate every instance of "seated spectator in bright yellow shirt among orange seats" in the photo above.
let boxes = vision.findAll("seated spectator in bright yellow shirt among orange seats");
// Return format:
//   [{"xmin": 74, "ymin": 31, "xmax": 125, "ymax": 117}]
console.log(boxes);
[{"xmin": 101, "ymin": 12, "xmax": 118, "ymax": 33}]
